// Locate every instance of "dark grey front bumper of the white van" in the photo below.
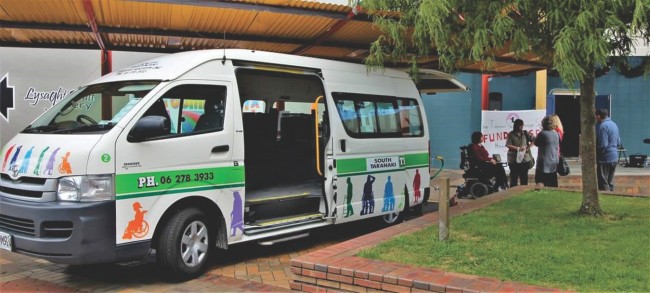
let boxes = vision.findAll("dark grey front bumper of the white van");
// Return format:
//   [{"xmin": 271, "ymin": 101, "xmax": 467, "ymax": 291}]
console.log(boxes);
[{"xmin": 0, "ymin": 197, "xmax": 150, "ymax": 265}]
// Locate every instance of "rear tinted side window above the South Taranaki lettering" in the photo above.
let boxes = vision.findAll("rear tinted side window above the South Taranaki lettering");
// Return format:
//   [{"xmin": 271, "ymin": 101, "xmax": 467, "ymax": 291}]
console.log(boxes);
[{"xmin": 332, "ymin": 93, "xmax": 424, "ymax": 138}]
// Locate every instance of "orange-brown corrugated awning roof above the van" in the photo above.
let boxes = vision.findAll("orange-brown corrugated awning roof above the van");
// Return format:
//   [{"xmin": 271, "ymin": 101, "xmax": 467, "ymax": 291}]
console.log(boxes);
[{"xmin": 0, "ymin": 0, "xmax": 546, "ymax": 74}]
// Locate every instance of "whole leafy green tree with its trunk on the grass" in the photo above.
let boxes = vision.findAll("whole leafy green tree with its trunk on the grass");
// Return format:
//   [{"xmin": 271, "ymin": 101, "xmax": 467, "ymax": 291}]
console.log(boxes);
[{"xmin": 360, "ymin": 0, "xmax": 650, "ymax": 216}]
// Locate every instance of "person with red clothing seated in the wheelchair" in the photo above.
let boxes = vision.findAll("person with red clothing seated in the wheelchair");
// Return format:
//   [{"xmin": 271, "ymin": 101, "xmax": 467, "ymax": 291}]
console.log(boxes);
[{"xmin": 467, "ymin": 131, "xmax": 508, "ymax": 189}]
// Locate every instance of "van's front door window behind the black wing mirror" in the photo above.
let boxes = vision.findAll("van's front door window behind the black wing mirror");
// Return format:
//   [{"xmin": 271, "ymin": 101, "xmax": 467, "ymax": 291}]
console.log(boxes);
[{"xmin": 143, "ymin": 84, "xmax": 226, "ymax": 135}]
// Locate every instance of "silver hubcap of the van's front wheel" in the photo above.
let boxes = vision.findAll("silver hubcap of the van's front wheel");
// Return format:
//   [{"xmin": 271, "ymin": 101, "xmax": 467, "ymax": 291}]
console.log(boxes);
[{"xmin": 181, "ymin": 221, "xmax": 208, "ymax": 267}]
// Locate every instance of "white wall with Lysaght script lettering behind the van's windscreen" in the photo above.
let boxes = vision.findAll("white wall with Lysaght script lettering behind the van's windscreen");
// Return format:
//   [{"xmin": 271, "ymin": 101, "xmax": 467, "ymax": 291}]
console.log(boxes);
[{"xmin": 0, "ymin": 47, "xmax": 161, "ymax": 149}]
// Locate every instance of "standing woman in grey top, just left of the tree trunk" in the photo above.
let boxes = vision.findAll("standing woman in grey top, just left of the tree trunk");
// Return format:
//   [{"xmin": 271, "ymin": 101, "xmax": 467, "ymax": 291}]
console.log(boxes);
[{"xmin": 535, "ymin": 116, "xmax": 560, "ymax": 187}]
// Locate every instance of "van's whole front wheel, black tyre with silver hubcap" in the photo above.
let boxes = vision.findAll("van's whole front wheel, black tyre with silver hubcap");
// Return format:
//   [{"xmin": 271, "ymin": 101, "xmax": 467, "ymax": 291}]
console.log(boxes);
[{"xmin": 156, "ymin": 208, "xmax": 209, "ymax": 280}]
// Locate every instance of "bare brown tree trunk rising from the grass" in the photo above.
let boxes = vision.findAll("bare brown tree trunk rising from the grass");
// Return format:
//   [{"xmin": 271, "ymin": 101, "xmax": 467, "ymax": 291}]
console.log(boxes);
[{"xmin": 580, "ymin": 65, "xmax": 603, "ymax": 216}]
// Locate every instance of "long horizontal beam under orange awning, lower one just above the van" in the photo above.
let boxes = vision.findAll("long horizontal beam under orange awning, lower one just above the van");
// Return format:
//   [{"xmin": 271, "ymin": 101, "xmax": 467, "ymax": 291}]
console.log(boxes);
[{"xmin": 0, "ymin": 20, "xmax": 369, "ymax": 50}]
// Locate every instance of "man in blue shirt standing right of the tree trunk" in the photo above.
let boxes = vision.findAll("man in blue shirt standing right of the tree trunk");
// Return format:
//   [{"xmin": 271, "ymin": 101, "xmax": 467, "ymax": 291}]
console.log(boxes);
[{"xmin": 596, "ymin": 109, "xmax": 620, "ymax": 191}]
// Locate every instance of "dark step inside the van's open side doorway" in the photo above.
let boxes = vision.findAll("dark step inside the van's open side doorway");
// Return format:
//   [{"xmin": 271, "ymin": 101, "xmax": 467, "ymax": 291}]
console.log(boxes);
[{"xmin": 244, "ymin": 195, "xmax": 322, "ymax": 224}]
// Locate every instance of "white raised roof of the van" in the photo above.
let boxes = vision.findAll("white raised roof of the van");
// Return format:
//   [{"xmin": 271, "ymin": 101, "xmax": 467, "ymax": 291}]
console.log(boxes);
[{"xmin": 90, "ymin": 49, "xmax": 409, "ymax": 84}]
